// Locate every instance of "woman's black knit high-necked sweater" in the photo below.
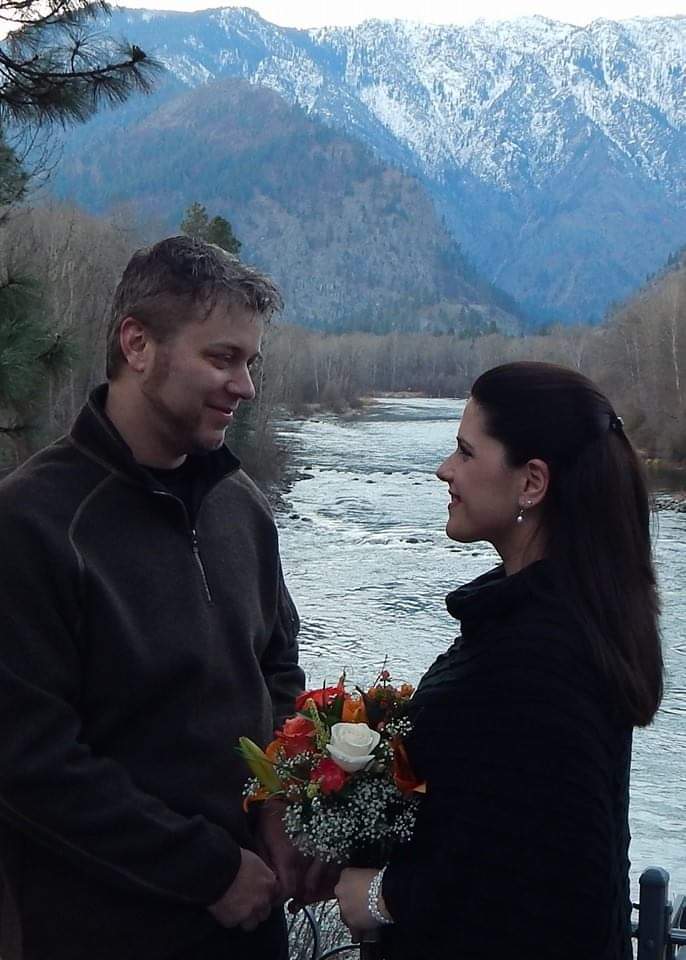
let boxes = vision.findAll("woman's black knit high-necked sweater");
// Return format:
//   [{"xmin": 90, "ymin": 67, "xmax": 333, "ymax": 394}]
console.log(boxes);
[{"xmin": 383, "ymin": 561, "xmax": 631, "ymax": 960}]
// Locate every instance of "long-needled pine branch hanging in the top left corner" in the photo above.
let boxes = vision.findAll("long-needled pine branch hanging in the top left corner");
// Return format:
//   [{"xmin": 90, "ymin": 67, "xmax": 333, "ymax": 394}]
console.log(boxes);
[{"xmin": 0, "ymin": 0, "xmax": 160, "ymax": 124}]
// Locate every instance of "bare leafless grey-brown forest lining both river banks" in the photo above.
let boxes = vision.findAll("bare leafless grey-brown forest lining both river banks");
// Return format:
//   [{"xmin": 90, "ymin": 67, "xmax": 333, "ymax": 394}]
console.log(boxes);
[{"xmin": 0, "ymin": 203, "xmax": 686, "ymax": 488}]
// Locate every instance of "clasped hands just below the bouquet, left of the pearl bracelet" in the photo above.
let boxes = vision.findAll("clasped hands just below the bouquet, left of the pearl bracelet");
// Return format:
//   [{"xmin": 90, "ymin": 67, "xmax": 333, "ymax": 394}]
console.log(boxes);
[{"xmin": 209, "ymin": 800, "xmax": 340, "ymax": 931}]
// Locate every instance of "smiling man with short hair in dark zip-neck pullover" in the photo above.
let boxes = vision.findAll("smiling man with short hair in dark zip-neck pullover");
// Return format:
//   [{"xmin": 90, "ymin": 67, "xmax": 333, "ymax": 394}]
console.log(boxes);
[{"xmin": 0, "ymin": 237, "xmax": 303, "ymax": 960}]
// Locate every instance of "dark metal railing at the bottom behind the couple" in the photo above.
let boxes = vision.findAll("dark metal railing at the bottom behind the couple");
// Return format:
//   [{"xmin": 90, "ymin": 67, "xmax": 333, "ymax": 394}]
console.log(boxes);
[{"xmin": 290, "ymin": 867, "xmax": 686, "ymax": 960}]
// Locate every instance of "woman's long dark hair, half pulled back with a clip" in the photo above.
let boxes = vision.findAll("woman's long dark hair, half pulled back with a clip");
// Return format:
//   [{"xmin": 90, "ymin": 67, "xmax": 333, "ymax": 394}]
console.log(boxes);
[{"xmin": 472, "ymin": 362, "xmax": 663, "ymax": 726}]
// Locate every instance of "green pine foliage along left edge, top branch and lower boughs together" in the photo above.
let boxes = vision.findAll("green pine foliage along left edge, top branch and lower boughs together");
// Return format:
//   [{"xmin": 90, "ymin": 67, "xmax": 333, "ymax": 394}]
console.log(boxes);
[{"xmin": 0, "ymin": 0, "xmax": 160, "ymax": 460}]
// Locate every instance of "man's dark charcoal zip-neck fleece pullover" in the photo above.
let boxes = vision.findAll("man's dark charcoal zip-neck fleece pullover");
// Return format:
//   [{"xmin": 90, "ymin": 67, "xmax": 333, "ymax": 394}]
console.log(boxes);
[{"xmin": 0, "ymin": 391, "xmax": 303, "ymax": 960}]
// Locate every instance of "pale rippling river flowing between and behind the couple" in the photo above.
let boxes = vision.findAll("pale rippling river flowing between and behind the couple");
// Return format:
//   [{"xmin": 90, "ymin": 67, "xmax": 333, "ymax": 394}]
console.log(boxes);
[{"xmin": 278, "ymin": 398, "xmax": 686, "ymax": 899}]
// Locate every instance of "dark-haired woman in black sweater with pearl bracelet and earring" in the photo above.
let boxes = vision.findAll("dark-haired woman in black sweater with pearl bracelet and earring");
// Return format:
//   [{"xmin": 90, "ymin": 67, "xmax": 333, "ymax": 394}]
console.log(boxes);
[{"xmin": 336, "ymin": 363, "xmax": 662, "ymax": 960}]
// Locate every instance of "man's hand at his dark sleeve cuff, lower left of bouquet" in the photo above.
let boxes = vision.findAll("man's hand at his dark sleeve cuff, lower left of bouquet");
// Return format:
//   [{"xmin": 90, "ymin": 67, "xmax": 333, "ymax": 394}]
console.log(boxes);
[{"xmin": 207, "ymin": 848, "xmax": 279, "ymax": 931}]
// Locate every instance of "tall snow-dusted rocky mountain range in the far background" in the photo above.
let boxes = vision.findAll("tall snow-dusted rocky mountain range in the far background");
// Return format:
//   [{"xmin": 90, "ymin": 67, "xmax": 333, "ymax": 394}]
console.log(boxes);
[{"xmin": 87, "ymin": 8, "xmax": 686, "ymax": 321}]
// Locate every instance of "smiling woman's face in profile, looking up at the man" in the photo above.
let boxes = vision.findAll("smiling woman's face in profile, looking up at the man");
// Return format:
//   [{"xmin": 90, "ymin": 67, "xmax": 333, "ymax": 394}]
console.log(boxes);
[{"xmin": 436, "ymin": 399, "xmax": 526, "ymax": 558}]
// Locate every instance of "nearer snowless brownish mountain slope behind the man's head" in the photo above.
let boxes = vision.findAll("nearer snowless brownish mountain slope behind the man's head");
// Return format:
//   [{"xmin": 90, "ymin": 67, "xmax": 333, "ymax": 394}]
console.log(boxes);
[{"xmin": 54, "ymin": 79, "xmax": 520, "ymax": 334}]
